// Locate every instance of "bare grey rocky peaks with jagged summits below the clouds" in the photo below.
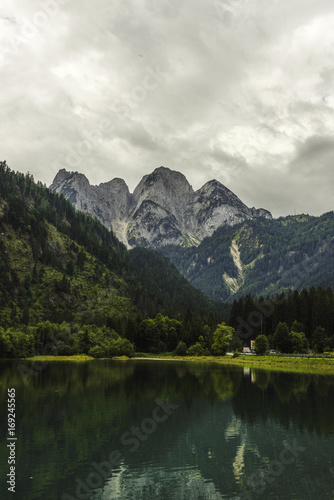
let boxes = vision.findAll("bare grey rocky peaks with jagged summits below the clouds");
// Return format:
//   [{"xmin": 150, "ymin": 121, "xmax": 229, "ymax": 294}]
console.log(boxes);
[{"xmin": 50, "ymin": 167, "xmax": 272, "ymax": 248}]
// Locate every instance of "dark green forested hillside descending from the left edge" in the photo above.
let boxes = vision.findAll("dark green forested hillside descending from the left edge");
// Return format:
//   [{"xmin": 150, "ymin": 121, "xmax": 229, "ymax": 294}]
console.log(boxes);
[{"xmin": 0, "ymin": 162, "xmax": 220, "ymax": 355}]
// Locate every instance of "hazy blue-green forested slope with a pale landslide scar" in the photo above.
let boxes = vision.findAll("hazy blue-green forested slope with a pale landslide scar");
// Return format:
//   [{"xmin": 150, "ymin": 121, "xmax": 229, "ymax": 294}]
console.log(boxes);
[{"xmin": 159, "ymin": 212, "xmax": 334, "ymax": 301}]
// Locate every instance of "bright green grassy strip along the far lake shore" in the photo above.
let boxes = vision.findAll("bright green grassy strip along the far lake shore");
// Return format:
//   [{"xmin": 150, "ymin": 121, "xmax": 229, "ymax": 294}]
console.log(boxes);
[{"xmin": 24, "ymin": 353, "xmax": 334, "ymax": 375}]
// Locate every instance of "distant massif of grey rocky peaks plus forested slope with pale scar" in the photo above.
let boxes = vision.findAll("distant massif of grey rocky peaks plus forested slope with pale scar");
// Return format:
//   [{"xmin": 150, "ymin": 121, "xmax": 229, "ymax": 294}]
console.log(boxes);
[{"xmin": 51, "ymin": 167, "xmax": 334, "ymax": 302}]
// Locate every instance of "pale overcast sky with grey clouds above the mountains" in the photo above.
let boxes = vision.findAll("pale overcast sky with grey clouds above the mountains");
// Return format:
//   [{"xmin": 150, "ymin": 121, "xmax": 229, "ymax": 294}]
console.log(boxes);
[{"xmin": 0, "ymin": 0, "xmax": 334, "ymax": 216}]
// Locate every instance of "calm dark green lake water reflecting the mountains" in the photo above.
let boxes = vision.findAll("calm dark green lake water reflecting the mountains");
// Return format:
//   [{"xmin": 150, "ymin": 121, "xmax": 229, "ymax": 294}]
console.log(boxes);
[{"xmin": 0, "ymin": 360, "xmax": 334, "ymax": 500}]
